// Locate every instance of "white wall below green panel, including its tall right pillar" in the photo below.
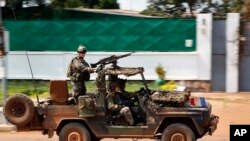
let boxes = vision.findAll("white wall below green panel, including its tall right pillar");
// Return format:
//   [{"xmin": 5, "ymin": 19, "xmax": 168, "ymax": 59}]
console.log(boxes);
[{"xmin": 1, "ymin": 14, "xmax": 212, "ymax": 80}]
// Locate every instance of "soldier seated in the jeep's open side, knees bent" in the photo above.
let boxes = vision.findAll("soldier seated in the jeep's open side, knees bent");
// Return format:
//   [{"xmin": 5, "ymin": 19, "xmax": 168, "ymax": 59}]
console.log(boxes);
[{"xmin": 106, "ymin": 81, "xmax": 134, "ymax": 126}]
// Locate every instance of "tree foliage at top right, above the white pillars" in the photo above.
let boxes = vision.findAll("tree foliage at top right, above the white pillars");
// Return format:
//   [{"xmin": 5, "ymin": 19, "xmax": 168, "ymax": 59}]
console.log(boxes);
[{"xmin": 142, "ymin": 0, "xmax": 250, "ymax": 17}]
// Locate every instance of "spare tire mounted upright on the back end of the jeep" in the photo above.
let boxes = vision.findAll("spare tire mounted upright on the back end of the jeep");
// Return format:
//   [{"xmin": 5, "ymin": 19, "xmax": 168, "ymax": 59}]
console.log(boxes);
[{"xmin": 3, "ymin": 94, "xmax": 35, "ymax": 126}]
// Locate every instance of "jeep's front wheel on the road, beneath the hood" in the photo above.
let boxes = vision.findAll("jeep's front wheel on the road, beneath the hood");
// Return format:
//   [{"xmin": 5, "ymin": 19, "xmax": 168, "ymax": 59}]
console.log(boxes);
[{"xmin": 161, "ymin": 123, "xmax": 196, "ymax": 141}]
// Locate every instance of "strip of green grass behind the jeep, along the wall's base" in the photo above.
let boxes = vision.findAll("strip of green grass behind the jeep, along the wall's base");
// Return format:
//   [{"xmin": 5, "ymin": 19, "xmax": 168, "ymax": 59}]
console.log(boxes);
[{"xmin": 0, "ymin": 80, "xmax": 159, "ymax": 106}]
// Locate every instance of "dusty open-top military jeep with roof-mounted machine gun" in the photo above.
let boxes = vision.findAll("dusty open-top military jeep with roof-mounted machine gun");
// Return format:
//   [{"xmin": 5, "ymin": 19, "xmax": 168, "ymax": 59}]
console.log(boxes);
[{"xmin": 3, "ymin": 54, "xmax": 219, "ymax": 141}]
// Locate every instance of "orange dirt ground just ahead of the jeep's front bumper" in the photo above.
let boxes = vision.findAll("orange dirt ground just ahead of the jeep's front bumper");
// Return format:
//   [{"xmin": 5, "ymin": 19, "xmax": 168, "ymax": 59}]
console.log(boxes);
[{"xmin": 198, "ymin": 99, "xmax": 250, "ymax": 141}]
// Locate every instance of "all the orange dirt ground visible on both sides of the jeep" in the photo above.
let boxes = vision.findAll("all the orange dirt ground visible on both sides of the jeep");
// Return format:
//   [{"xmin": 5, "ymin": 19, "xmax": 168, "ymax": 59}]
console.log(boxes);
[{"xmin": 0, "ymin": 94, "xmax": 250, "ymax": 141}]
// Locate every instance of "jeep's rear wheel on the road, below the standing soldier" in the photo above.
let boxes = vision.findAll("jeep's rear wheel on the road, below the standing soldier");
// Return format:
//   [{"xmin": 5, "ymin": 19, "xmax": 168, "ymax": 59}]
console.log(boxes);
[{"xmin": 59, "ymin": 122, "xmax": 91, "ymax": 141}]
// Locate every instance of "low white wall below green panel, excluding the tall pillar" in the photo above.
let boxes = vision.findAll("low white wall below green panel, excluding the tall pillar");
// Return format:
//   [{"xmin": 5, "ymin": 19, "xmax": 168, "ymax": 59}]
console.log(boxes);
[{"xmin": 5, "ymin": 52, "xmax": 200, "ymax": 80}]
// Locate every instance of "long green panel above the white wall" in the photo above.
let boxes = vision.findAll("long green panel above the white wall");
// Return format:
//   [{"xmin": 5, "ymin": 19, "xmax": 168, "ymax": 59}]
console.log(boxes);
[{"xmin": 4, "ymin": 18, "xmax": 196, "ymax": 52}]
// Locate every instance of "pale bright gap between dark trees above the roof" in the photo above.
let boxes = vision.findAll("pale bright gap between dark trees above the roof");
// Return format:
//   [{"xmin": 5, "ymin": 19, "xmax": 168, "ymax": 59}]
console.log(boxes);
[{"xmin": 117, "ymin": 0, "xmax": 148, "ymax": 11}]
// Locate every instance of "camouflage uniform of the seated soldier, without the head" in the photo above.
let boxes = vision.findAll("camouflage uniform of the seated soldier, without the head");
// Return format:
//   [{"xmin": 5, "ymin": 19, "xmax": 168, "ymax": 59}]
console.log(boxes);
[{"xmin": 106, "ymin": 92, "xmax": 134, "ymax": 125}]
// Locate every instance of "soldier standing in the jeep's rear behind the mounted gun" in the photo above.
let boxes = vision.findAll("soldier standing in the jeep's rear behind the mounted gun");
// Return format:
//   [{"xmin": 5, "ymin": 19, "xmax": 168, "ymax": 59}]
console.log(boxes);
[{"xmin": 67, "ymin": 44, "xmax": 95, "ymax": 101}]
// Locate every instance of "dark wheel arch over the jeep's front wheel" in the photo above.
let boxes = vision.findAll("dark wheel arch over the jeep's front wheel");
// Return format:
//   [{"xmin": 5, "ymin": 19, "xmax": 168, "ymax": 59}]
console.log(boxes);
[{"xmin": 155, "ymin": 117, "xmax": 201, "ymax": 138}]
